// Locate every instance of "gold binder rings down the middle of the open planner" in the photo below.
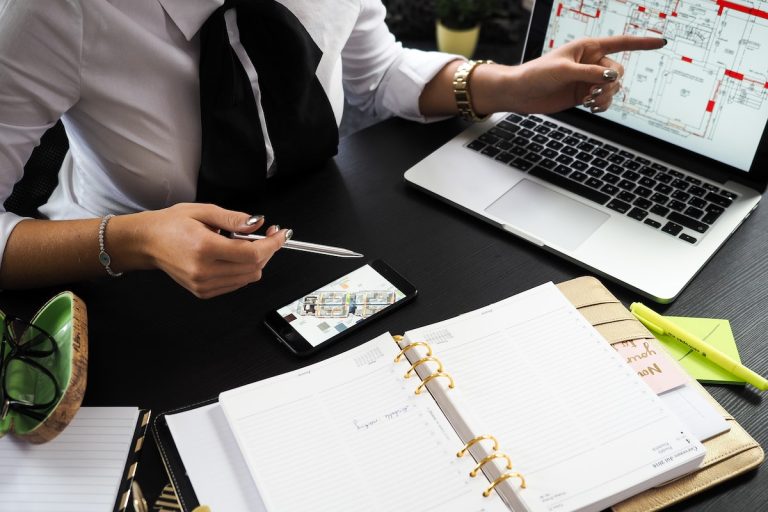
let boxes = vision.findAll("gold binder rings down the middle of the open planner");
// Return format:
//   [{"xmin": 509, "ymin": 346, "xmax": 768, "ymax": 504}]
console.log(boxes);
[{"xmin": 392, "ymin": 335, "xmax": 525, "ymax": 497}]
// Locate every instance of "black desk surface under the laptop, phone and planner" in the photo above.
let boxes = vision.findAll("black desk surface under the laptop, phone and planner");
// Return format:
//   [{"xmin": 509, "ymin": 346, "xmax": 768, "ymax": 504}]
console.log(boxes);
[{"xmin": 0, "ymin": 120, "xmax": 768, "ymax": 512}]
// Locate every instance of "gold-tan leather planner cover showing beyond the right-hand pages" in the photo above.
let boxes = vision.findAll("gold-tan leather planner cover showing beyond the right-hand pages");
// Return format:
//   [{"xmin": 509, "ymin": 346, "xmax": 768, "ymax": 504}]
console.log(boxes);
[{"xmin": 557, "ymin": 277, "xmax": 764, "ymax": 512}]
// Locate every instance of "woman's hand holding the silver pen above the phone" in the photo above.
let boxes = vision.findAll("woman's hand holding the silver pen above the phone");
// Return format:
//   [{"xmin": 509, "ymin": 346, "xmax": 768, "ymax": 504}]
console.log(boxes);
[{"xmin": 124, "ymin": 203, "xmax": 292, "ymax": 298}]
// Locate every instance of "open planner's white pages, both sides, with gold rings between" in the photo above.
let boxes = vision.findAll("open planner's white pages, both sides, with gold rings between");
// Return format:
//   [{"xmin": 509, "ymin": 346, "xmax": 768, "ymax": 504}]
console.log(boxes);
[{"xmin": 155, "ymin": 283, "xmax": 728, "ymax": 512}]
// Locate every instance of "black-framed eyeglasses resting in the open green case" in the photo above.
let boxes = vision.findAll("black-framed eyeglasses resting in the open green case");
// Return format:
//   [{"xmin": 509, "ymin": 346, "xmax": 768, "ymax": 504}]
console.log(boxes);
[{"xmin": 0, "ymin": 317, "xmax": 61, "ymax": 421}]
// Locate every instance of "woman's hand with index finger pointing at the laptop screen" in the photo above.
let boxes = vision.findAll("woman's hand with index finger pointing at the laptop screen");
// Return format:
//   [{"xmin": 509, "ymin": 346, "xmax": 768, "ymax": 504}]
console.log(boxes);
[{"xmin": 480, "ymin": 36, "xmax": 666, "ymax": 114}]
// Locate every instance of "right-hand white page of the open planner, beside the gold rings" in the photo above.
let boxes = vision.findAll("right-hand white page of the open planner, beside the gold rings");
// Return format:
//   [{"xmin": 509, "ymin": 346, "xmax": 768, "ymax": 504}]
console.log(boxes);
[{"xmin": 406, "ymin": 283, "xmax": 705, "ymax": 511}]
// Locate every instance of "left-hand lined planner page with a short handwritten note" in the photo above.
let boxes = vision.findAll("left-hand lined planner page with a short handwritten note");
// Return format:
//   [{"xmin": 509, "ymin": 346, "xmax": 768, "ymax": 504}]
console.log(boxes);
[{"xmin": 219, "ymin": 334, "xmax": 507, "ymax": 512}]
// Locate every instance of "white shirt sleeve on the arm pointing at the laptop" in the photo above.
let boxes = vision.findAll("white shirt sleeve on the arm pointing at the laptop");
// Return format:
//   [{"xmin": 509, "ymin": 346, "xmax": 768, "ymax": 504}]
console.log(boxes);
[{"xmin": 342, "ymin": 0, "xmax": 464, "ymax": 122}]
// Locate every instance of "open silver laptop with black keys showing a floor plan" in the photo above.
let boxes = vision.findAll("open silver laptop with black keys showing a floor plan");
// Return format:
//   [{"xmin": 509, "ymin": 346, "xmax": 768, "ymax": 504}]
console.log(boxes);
[{"xmin": 405, "ymin": 0, "xmax": 768, "ymax": 303}]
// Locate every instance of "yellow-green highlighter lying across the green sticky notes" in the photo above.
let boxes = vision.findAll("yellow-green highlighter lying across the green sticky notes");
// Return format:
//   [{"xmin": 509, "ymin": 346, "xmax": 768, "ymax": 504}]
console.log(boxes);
[{"xmin": 629, "ymin": 302, "xmax": 768, "ymax": 391}]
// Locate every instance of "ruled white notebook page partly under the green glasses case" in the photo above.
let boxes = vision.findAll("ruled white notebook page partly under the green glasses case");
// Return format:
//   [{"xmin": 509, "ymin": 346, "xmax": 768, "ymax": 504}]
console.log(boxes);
[{"xmin": 0, "ymin": 407, "xmax": 139, "ymax": 512}]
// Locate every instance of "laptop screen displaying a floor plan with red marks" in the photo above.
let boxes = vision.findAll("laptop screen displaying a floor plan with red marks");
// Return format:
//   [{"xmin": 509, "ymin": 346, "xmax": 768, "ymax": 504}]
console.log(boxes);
[{"xmin": 526, "ymin": 0, "xmax": 768, "ymax": 178}]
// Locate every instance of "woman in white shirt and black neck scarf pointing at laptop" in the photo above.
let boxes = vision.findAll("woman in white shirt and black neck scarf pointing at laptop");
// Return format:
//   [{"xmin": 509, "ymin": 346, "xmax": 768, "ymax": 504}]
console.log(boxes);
[{"xmin": 0, "ymin": 0, "xmax": 664, "ymax": 298}]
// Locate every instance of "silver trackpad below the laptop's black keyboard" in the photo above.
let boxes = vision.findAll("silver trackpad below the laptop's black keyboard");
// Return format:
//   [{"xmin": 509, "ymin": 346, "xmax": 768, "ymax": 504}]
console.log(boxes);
[{"xmin": 485, "ymin": 179, "xmax": 610, "ymax": 251}]
